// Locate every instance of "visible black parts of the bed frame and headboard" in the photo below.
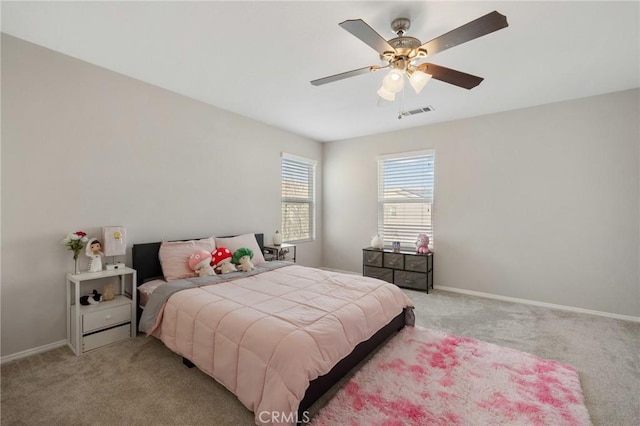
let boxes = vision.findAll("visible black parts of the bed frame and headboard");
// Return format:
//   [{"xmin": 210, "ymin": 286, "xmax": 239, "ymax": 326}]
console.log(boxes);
[{"xmin": 132, "ymin": 234, "xmax": 405, "ymax": 419}]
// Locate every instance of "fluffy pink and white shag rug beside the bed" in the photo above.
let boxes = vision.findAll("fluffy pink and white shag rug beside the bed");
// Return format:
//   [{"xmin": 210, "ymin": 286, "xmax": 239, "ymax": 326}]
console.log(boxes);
[{"xmin": 311, "ymin": 327, "xmax": 591, "ymax": 426}]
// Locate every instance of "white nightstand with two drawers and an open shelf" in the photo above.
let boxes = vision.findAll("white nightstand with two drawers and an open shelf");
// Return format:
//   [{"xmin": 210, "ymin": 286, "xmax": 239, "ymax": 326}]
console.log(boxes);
[{"xmin": 67, "ymin": 268, "xmax": 137, "ymax": 355}]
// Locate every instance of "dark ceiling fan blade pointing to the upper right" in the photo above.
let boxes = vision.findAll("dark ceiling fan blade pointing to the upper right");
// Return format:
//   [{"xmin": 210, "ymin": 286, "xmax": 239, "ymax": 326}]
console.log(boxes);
[{"xmin": 420, "ymin": 10, "xmax": 509, "ymax": 56}]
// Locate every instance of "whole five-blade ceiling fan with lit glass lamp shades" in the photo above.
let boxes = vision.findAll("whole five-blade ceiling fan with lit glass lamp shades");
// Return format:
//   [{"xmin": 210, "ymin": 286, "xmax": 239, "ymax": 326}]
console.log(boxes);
[{"xmin": 311, "ymin": 11, "xmax": 509, "ymax": 101}]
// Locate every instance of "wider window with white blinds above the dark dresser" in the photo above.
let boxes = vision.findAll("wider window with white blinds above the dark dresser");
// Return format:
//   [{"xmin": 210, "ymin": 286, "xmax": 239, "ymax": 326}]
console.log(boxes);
[{"xmin": 378, "ymin": 150, "xmax": 435, "ymax": 247}]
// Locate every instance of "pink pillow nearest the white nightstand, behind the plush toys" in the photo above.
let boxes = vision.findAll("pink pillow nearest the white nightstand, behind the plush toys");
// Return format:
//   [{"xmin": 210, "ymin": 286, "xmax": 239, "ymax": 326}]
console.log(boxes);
[{"xmin": 158, "ymin": 237, "xmax": 216, "ymax": 281}]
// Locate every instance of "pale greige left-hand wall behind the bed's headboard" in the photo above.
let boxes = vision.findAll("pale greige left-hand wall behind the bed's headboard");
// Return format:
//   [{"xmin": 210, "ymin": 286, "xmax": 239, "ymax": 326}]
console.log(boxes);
[{"xmin": 1, "ymin": 34, "xmax": 322, "ymax": 356}]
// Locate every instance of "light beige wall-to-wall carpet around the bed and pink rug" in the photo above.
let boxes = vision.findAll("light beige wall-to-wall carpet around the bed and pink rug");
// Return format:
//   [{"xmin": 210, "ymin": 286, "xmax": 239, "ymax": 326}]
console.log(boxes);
[{"xmin": 0, "ymin": 290, "xmax": 640, "ymax": 426}]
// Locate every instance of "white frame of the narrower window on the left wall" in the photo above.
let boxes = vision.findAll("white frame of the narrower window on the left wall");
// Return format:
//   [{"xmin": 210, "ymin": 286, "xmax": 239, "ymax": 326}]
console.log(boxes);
[{"xmin": 280, "ymin": 152, "xmax": 318, "ymax": 244}]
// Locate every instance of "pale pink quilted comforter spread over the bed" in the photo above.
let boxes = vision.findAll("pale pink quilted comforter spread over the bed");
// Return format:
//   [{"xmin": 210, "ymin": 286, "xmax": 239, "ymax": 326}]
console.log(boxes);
[{"xmin": 153, "ymin": 265, "xmax": 413, "ymax": 425}]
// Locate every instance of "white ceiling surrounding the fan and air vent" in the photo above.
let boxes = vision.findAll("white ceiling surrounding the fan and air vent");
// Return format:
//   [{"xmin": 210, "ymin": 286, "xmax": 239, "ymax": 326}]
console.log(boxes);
[{"xmin": 1, "ymin": 1, "xmax": 640, "ymax": 141}]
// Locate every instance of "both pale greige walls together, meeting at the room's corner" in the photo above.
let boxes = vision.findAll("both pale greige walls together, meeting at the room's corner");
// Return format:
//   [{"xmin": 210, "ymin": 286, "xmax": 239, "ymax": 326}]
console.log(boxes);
[{"xmin": 0, "ymin": 34, "xmax": 640, "ymax": 356}]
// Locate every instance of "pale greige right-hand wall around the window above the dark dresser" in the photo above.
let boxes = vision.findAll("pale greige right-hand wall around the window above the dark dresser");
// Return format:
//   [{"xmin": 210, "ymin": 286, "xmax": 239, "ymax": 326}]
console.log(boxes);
[{"xmin": 323, "ymin": 89, "xmax": 640, "ymax": 316}]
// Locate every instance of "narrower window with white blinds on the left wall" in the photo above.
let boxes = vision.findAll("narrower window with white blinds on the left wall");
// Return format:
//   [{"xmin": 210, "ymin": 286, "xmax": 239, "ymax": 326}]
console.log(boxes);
[{"xmin": 282, "ymin": 153, "xmax": 316, "ymax": 242}]
